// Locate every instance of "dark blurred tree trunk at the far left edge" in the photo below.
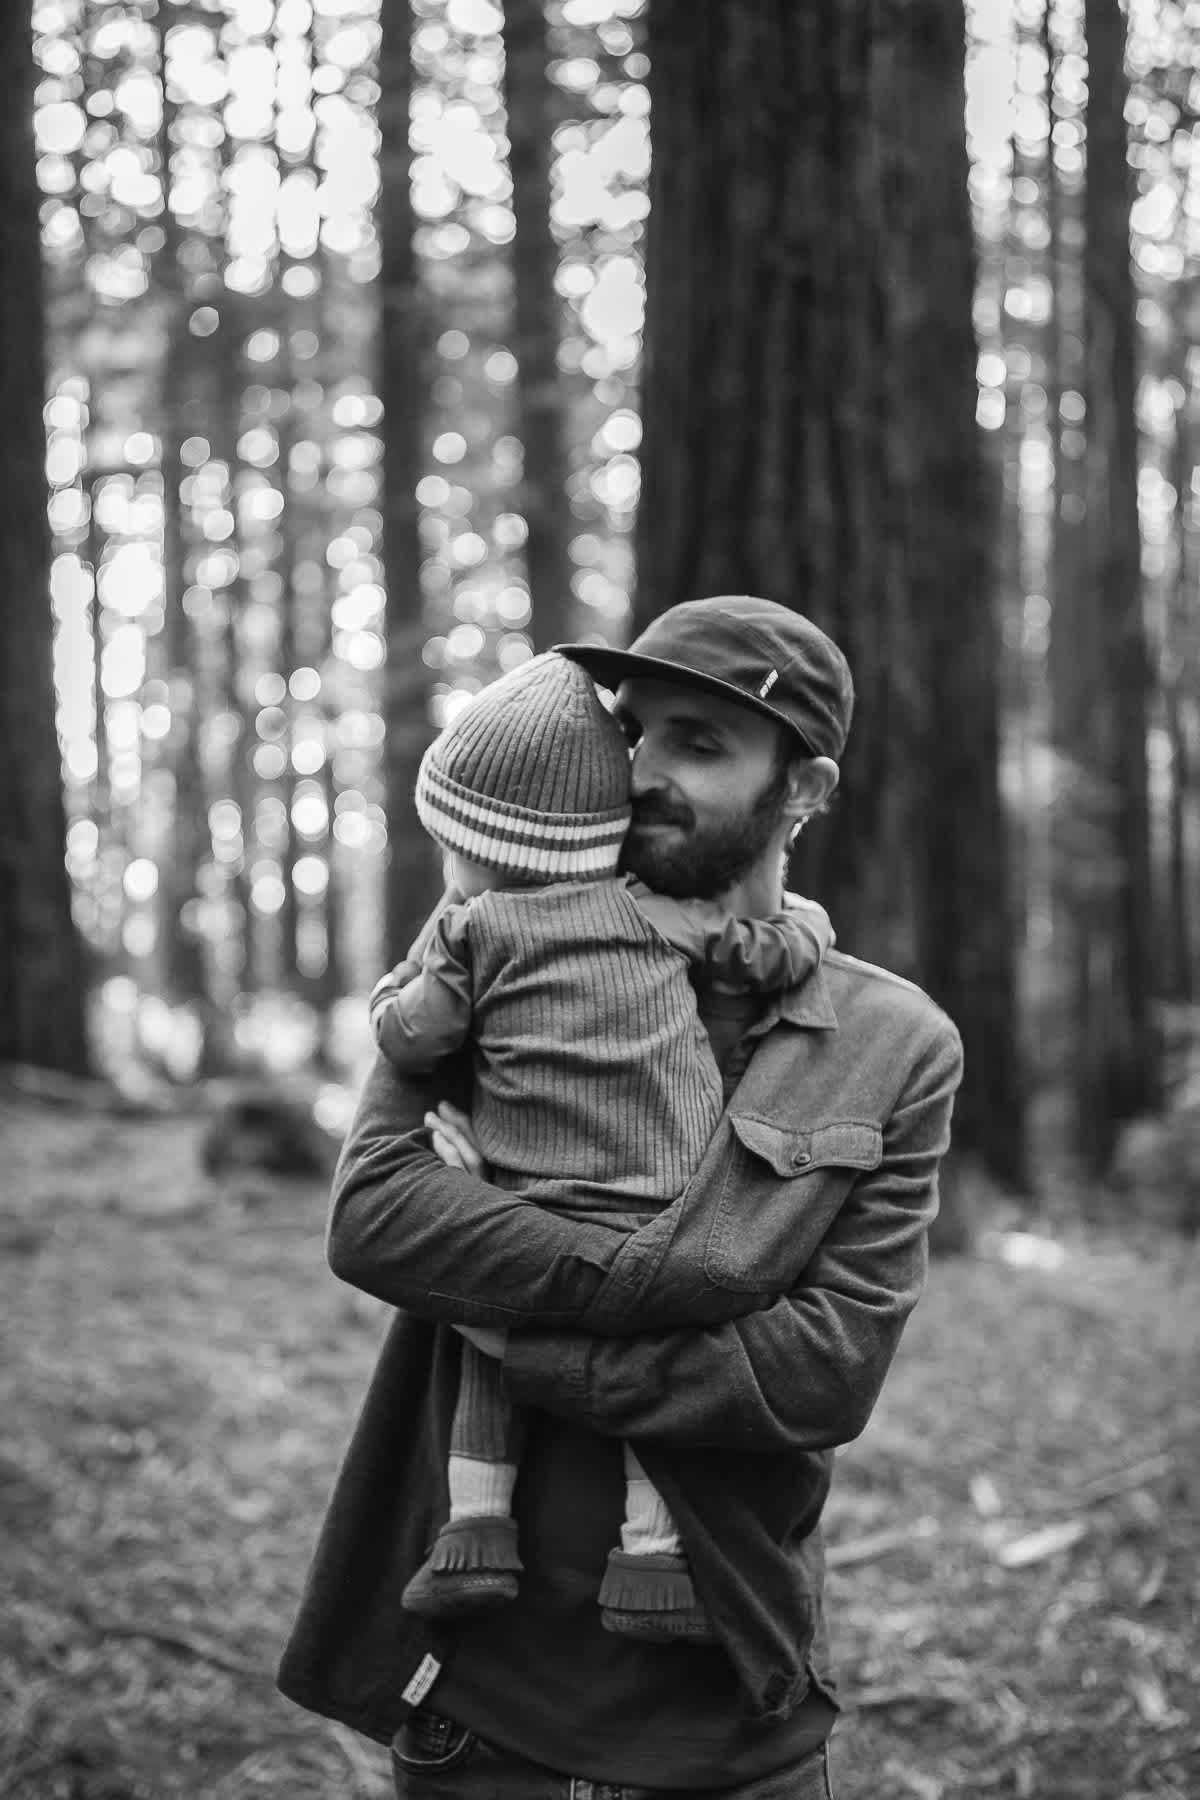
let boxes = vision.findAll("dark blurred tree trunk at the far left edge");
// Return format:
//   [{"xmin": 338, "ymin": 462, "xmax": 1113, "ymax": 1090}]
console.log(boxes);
[{"xmin": 0, "ymin": 5, "xmax": 88, "ymax": 1073}]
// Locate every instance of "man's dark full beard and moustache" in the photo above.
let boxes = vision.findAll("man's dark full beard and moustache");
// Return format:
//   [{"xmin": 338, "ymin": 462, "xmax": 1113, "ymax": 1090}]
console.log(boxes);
[{"xmin": 621, "ymin": 765, "xmax": 788, "ymax": 900}]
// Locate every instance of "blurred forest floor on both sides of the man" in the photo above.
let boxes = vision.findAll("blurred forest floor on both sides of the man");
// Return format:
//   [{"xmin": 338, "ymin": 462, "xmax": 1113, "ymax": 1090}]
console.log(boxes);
[{"xmin": 0, "ymin": 1087, "xmax": 1200, "ymax": 1800}]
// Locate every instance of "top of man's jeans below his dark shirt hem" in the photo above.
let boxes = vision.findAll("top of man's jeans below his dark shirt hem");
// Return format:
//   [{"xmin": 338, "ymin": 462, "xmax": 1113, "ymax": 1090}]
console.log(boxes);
[{"xmin": 392, "ymin": 1706, "xmax": 833, "ymax": 1800}]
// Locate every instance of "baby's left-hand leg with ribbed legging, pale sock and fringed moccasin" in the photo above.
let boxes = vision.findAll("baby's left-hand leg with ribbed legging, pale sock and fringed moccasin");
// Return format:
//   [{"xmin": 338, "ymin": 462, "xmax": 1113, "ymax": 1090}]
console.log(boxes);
[{"xmin": 401, "ymin": 1343, "xmax": 522, "ymax": 1618}]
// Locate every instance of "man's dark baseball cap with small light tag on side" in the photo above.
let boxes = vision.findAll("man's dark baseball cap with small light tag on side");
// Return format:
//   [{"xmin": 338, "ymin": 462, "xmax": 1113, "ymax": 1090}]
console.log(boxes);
[{"xmin": 556, "ymin": 594, "xmax": 855, "ymax": 760}]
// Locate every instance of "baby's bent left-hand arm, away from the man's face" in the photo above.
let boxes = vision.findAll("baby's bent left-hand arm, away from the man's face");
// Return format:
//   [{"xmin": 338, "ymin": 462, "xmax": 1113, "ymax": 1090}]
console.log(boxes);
[{"xmin": 371, "ymin": 900, "xmax": 471, "ymax": 1073}]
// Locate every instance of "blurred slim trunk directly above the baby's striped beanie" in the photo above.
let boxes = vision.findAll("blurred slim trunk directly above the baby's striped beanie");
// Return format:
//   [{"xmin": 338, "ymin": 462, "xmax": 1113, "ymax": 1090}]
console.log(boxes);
[{"xmin": 504, "ymin": 0, "xmax": 572, "ymax": 650}]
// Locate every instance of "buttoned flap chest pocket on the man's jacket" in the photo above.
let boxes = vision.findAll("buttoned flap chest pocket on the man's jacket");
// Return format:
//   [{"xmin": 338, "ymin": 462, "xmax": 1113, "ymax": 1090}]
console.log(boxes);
[{"xmin": 703, "ymin": 1112, "xmax": 883, "ymax": 1294}]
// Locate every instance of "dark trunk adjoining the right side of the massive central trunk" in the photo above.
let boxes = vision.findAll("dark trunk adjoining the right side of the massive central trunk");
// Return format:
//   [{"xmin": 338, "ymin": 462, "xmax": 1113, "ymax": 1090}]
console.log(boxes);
[{"xmin": 871, "ymin": 10, "xmax": 1027, "ymax": 1184}]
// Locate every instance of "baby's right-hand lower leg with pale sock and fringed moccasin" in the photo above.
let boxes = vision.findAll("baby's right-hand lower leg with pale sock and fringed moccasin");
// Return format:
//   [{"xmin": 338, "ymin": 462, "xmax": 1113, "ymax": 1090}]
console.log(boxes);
[{"xmin": 599, "ymin": 1444, "xmax": 714, "ymax": 1643}]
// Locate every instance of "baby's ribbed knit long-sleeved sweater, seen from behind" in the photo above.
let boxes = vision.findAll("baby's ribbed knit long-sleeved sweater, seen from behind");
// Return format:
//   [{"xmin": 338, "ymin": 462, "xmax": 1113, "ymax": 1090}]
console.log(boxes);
[{"xmin": 372, "ymin": 880, "xmax": 831, "ymax": 1215}]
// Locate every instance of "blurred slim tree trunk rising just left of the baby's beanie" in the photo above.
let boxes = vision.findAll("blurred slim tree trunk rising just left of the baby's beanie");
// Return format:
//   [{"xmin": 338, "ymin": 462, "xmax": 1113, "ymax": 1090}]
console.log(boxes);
[{"xmin": 378, "ymin": 0, "xmax": 439, "ymax": 958}]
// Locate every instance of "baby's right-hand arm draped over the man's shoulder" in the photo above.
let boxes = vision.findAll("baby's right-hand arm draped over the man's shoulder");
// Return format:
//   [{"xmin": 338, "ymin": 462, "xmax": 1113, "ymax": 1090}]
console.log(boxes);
[{"xmin": 631, "ymin": 884, "xmax": 833, "ymax": 992}]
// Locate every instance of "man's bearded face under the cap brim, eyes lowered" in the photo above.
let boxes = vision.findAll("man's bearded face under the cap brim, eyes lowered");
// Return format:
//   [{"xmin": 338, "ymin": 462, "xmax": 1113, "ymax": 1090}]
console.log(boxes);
[{"xmin": 615, "ymin": 680, "xmax": 788, "ymax": 900}]
